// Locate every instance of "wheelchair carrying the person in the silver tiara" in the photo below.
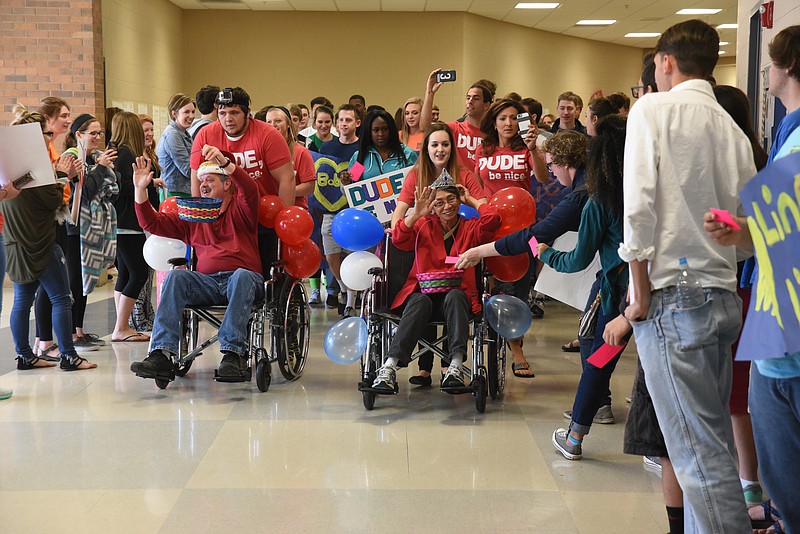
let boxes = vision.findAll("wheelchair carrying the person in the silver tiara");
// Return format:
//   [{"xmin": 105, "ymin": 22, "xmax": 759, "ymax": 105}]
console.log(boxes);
[{"xmin": 358, "ymin": 234, "xmax": 506, "ymax": 413}]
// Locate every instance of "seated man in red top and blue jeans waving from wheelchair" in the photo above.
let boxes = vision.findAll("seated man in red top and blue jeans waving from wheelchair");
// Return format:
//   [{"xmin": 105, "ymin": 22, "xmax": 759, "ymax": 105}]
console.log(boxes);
[{"xmin": 131, "ymin": 145, "xmax": 264, "ymax": 386}]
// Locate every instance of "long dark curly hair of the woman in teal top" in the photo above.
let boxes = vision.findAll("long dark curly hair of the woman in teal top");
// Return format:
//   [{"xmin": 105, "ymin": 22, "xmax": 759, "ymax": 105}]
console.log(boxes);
[{"xmin": 586, "ymin": 115, "xmax": 626, "ymax": 215}]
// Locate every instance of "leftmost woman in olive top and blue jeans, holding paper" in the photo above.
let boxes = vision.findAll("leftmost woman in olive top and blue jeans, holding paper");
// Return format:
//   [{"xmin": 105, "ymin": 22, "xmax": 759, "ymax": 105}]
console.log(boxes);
[{"xmin": 0, "ymin": 104, "xmax": 97, "ymax": 371}]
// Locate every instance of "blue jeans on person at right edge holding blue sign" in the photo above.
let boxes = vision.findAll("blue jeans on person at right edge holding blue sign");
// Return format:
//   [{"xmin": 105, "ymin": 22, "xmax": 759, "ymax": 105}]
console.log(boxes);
[{"xmin": 750, "ymin": 365, "xmax": 800, "ymax": 534}]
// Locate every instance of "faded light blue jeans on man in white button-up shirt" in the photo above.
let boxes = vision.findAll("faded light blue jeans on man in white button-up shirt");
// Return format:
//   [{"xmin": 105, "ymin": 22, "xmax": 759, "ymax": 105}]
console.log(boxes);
[{"xmin": 633, "ymin": 287, "xmax": 752, "ymax": 534}]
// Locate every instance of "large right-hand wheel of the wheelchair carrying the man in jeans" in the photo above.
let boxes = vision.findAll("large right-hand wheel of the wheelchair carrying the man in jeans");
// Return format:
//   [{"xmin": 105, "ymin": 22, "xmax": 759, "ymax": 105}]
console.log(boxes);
[{"xmin": 271, "ymin": 277, "xmax": 311, "ymax": 380}]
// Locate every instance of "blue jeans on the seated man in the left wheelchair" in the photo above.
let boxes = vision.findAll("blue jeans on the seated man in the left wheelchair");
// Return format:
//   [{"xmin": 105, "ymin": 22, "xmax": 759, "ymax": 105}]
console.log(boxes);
[{"xmin": 150, "ymin": 269, "xmax": 264, "ymax": 356}]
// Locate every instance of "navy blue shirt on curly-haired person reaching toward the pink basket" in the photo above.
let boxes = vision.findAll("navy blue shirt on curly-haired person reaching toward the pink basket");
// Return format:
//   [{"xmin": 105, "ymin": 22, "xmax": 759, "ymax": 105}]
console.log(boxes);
[{"xmin": 494, "ymin": 167, "xmax": 589, "ymax": 256}]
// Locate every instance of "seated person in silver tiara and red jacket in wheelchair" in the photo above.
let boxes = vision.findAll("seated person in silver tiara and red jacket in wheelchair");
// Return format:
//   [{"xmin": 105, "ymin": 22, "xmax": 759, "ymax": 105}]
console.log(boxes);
[{"xmin": 371, "ymin": 172, "xmax": 501, "ymax": 394}]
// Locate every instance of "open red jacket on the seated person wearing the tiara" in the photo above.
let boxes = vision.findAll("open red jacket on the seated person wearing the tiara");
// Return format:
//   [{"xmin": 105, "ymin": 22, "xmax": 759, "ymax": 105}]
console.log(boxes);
[{"xmin": 391, "ymin": 204, "xmax": 501, "ymax": 313}]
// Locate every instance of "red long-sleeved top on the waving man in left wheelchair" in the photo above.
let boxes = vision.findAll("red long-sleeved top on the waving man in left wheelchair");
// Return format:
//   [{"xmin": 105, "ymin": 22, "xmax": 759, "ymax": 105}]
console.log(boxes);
[{"xmin": 136, "ymin": 165, "xmax": 261, "ymax": 274}]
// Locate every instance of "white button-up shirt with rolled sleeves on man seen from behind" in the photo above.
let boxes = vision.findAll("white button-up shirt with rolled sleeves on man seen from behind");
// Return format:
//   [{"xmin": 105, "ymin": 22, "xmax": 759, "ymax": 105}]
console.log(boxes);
[{"xmin": 619, "ymin": 80, "xmax": 756, "ymax": 291}]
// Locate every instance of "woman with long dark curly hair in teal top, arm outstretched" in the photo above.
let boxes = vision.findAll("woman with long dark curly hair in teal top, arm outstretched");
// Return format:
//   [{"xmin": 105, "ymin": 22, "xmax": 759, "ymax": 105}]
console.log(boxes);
[{"xmin": 537, "ymin": 115, "xmax": 628, "ymax": 460}]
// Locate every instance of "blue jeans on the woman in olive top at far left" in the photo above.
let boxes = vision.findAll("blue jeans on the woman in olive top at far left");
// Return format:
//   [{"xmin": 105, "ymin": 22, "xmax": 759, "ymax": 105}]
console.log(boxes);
[{"xmin": 11, "ymin": 245, "xmax": 78, "ymax": 359}]
